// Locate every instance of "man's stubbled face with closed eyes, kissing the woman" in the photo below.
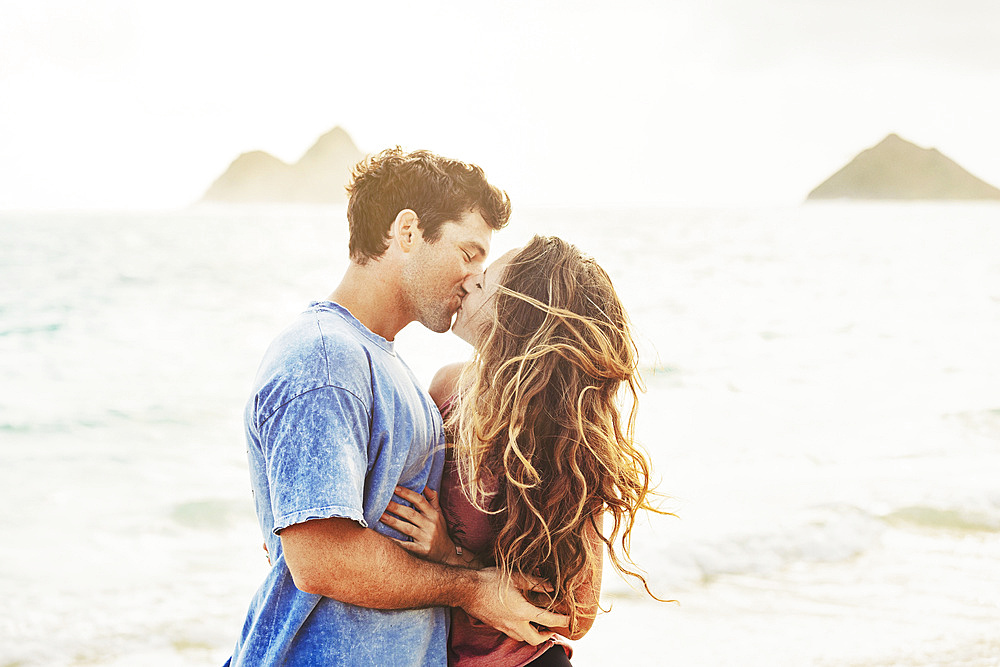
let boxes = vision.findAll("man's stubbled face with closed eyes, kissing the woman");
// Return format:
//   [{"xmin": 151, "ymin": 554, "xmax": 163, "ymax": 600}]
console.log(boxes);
[{"xmin": 403, "ymin": 211, "xmax": 493, "ymax": 333}]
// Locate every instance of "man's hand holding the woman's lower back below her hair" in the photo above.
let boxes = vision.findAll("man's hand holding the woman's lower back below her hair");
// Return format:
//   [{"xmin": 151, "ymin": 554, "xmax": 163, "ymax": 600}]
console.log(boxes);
[{"xmin": 462, "ymin": 568, "xmax": 569, "ymax": 646}]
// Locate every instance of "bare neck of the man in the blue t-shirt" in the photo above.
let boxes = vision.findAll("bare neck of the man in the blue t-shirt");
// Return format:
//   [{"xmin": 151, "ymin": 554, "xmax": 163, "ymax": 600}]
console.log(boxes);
[{"xmin": 327, "ymin": 261, "xmax": 413, "ymax": 341}]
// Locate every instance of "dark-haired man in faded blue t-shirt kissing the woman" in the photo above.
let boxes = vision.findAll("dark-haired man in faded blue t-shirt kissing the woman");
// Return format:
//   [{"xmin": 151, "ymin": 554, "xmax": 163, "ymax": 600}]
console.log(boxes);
[{"xmin": 229, "ymin": 148, "xmax": 566, "ymax": 667}]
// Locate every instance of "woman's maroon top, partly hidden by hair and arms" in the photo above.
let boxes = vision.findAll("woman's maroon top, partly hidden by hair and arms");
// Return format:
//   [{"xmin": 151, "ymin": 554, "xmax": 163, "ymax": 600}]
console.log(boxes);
[{"xmin": 440, "ymin": 399, "xmax": 573, "ymax": 667}]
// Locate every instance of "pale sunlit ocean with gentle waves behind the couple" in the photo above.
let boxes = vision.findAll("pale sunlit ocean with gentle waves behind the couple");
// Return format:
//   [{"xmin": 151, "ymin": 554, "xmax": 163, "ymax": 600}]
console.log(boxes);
[{"xmin": 0, "ymin": 203, "xmax": 1000, "ymax": 667}]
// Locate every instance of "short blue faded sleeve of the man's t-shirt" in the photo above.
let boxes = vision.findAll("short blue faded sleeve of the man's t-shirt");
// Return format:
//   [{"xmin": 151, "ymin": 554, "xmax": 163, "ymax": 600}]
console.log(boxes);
[{"xmin": 260, "ymin": 386, "xmax": 371, "ymax": 534}]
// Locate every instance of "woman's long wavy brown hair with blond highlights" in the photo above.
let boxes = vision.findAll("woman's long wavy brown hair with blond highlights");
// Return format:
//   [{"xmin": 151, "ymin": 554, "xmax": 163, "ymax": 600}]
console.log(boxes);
[{"xmin": 449, "ymin": 236, "xmax": 662, "ymax": 629}]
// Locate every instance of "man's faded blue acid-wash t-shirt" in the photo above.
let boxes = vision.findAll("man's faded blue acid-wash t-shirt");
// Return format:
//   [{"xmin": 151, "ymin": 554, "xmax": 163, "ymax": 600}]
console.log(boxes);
[{"xmin": 231, "ymin": 301, "xmax": 448, "ymax": 667}]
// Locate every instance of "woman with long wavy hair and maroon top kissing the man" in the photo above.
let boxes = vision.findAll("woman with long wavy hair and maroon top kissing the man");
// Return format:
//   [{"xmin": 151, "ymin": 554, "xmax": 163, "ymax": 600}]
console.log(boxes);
[{"xmin": 382, "ymin": 236, "xmax": 658, "ymax": 667}]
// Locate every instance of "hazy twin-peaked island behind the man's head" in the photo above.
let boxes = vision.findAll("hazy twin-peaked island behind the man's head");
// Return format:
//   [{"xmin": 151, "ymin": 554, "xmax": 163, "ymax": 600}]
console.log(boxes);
[{"xmin": 201, "ymin": 127, "xmax": 364, "ymax": 204}]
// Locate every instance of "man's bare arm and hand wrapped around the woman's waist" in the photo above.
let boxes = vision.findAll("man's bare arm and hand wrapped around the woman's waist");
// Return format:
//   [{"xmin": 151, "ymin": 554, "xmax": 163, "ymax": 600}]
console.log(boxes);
[{"xmin": 280, "ymin": 518, "xmax": 569, "ymax": 645}]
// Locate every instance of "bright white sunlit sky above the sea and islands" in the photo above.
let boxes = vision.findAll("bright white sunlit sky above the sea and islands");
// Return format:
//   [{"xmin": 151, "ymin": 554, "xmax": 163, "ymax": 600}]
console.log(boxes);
[{"xmin": 0, "ymin": 0, "xmax": 1000, "ymax": 209}]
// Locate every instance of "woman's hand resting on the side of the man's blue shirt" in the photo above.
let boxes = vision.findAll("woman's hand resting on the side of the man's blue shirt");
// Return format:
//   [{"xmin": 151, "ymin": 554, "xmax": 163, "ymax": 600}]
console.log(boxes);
[{"xmin": 381, "ymin": 486, "xmax": 466, "ymax": 566}]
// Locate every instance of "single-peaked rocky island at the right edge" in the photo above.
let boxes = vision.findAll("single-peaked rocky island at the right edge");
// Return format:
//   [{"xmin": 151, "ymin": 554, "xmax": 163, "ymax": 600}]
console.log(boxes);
[{"xmin": 807, "ymin": 134, "xmax": 1000, "ymax": 200}]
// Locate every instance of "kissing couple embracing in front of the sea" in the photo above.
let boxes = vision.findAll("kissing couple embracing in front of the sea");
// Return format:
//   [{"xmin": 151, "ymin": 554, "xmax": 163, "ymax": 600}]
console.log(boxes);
[{"xmin": 226, "ymin": 148, "xmax": 658, "ymax": 667}]
